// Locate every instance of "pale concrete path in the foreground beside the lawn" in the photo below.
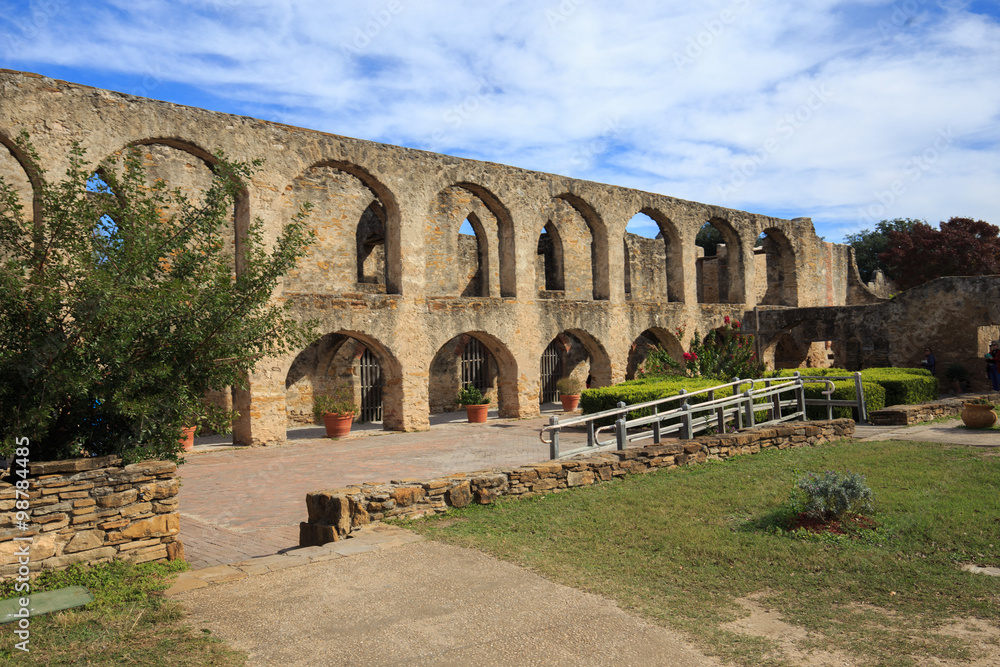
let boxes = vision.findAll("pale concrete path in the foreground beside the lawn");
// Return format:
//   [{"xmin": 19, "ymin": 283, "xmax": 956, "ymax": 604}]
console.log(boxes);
[{"xmin": 176, "ymin": 529, "xmax": 722, "ymax": 667}]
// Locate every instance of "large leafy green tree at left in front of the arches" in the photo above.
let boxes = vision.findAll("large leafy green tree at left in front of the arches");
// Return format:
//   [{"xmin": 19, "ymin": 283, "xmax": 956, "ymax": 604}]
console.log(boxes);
[{"xmin": 0, "ymin": 135, "xmax": 312, "ymax": 461}]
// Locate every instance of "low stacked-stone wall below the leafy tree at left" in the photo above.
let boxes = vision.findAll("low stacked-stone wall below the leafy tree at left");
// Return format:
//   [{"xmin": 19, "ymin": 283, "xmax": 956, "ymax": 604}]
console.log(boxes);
[{"xmin": 0, "ymin": 456, "xmax": 184, "ymax": 578}]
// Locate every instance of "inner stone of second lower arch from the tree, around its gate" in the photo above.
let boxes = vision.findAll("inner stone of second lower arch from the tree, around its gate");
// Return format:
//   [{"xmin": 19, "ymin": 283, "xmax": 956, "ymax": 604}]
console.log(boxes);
[{"xmin": 427, "ymin": 331, "xmax": 519, "ymax": 417}]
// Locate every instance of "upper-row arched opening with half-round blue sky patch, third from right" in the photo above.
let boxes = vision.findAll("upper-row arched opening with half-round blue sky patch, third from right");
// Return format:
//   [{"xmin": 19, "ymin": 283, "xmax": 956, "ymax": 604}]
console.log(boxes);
[{"xmin": 623, "ymin": 208, "xmax": 684, "ymax": 302}]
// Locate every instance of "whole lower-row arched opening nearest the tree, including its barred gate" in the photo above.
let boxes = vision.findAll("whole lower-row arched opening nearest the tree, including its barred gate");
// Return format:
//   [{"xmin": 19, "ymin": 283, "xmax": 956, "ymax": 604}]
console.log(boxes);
[{"xmin": 285, "ymin": 332, "xmax": 402, "ymax": 429}]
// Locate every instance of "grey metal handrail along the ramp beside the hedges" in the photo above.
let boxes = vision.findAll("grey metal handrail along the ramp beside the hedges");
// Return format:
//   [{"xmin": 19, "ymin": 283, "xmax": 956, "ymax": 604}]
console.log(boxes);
[{"xmin": 538, "ymin": 372, "xmax": 867, "ymax": 459}]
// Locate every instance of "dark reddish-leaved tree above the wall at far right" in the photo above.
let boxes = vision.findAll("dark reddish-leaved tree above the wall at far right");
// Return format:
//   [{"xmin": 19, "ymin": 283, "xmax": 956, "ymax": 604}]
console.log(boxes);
[{"xmin": 879, "ymin": 218, "xmax": 1000, "ymax": 289}]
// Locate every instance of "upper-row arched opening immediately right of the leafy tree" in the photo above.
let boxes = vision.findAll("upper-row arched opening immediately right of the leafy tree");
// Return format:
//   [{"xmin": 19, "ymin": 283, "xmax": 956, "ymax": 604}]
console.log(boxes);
[{"xmin": 284, "ymin": 160, "xmax": 401, "ymax": 294}]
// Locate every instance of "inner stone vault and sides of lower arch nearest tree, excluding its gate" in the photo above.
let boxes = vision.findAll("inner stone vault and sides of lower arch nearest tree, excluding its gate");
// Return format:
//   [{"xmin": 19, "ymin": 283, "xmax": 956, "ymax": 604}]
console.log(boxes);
[{"xmin": 285, "ymin": 329, "xmax": 403, "ymax": 430}]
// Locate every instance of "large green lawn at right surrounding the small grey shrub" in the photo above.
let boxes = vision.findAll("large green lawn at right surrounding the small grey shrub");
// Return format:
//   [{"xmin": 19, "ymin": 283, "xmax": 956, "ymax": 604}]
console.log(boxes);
[{"xmin": 408, "ymin": 441, "xmax": 1000, "ymax": 665}]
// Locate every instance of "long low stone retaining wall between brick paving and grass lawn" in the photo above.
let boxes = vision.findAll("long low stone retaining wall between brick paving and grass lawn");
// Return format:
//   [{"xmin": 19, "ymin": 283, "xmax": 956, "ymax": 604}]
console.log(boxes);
[{"xmin": 299, "ymin": 419, "xmax": 854, "ymax": 546}]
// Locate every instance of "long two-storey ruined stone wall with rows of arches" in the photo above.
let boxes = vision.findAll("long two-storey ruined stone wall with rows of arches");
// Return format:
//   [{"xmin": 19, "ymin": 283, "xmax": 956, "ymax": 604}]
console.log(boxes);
[{"xmin": 0, "ymin": 70, "xmax": 874, "ymax": 444}]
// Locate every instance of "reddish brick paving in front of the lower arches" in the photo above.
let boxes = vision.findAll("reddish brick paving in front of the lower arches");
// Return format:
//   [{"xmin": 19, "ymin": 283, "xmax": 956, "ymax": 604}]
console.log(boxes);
[{"xmin": 178, "ymin": 412, "xmax": 586, "ymax": 569}]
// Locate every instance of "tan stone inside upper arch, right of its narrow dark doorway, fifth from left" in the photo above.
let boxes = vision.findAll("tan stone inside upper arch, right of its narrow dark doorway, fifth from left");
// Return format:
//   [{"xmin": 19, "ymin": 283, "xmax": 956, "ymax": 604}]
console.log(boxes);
[{"xmin": 552, "ymin": 193, "xmax": 610, "ymax": 301}]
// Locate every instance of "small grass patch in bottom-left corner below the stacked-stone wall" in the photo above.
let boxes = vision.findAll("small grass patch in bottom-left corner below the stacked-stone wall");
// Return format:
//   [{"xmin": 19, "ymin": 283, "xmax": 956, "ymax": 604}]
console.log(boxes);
[{"xmin": 0, "ymin": 561, "xmax": 245, "ymax": 667}]
